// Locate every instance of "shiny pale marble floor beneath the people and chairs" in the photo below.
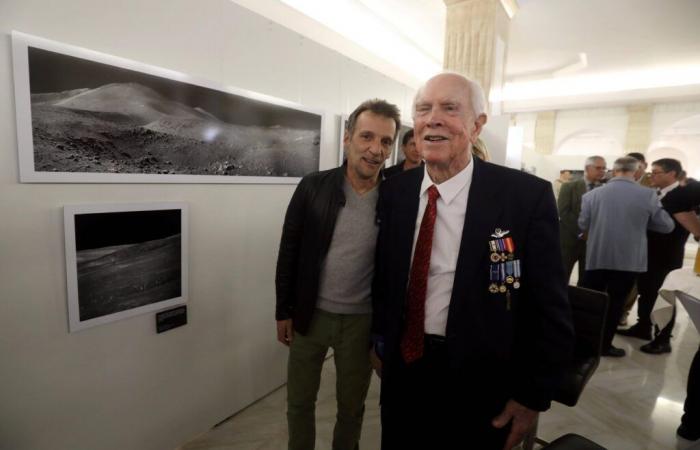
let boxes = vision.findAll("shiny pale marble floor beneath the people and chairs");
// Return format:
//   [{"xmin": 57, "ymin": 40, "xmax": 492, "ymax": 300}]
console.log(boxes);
[{"xmin": 181, "ymin": 249, "xmax": 700, "ymax": 450}]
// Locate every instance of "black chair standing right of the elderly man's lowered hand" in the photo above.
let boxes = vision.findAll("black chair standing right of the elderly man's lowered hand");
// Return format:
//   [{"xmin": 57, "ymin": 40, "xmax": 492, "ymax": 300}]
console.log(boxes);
[{"xmin": 523, "ymin": 286, "xmax": 608, "ymax": 450}]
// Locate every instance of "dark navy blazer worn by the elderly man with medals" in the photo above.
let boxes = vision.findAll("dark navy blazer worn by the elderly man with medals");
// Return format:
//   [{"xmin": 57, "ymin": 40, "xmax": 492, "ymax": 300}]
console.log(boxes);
[{"xmin": 373, "ymin": 158, "xmax": 574, "ymax": 411}]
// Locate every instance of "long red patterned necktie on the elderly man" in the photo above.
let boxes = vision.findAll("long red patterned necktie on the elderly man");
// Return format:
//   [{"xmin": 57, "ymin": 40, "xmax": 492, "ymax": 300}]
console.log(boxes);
[{"xmin": 401, "ymin": 185, "xmax": 440, "ymax": 363}]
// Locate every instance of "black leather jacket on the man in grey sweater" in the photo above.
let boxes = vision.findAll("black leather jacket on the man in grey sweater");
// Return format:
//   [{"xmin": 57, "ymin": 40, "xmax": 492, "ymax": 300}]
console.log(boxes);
[{"xmin": 275, "ymin": 165, "xmax": 346, "ymax": 335}]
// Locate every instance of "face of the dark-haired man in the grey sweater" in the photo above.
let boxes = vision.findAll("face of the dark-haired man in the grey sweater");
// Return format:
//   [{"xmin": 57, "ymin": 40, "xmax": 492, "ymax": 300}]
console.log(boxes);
[{"xmin": 343, "ymin": 111, "xmax": 396, "ymax": 180}]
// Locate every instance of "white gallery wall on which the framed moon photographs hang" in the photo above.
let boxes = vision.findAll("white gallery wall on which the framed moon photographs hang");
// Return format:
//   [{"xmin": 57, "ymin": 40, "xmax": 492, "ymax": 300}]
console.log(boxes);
[{"xmin": 0, "ymin": 0, "xmax": 414, "ymax": 450}]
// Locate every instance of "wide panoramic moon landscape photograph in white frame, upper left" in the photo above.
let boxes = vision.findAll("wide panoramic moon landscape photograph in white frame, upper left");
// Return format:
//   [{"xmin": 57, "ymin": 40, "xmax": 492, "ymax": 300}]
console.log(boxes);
[{"xmin": 13, "ymin": 33, "xmax": 322, "ymax": 183}]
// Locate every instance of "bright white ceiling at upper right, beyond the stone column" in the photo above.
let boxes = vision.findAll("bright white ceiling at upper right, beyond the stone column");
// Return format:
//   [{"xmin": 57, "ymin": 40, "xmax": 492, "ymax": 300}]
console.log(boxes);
[{"xmin": 506, "ymin": 0, "xmax": 700, "ymax": 80}]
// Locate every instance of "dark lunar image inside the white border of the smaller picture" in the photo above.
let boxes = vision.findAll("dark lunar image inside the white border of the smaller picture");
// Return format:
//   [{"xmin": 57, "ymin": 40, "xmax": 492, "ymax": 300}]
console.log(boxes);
[{"xmin": 74, "ymin": 209, "xmax": 182, "ymax": 322}]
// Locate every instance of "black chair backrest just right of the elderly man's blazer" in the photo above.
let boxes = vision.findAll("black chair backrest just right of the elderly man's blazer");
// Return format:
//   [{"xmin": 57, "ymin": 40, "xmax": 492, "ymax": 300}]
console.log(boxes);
[{"xmin": 569, "ymin": 286, "xmax": 608, "ymax": 358}]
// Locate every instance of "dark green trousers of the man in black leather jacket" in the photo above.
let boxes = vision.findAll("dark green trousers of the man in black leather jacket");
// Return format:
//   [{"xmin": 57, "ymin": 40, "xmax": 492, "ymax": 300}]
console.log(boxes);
[{"xmin": 287, "ymin": 309, "xmax": 372, "ymax": 450}]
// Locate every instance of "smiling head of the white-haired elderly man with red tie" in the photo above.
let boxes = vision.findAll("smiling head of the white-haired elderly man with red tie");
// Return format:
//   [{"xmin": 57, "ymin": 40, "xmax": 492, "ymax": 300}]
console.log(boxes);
[{"xmin": 413, "ymin": 74, "xmax": 486, "ymax": 173}]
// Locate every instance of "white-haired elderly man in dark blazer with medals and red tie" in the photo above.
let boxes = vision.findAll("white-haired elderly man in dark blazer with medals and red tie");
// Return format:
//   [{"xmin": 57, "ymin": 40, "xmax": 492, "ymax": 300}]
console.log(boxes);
[{"xmin": 373, "ymin": 73, "xmax": 573, "ymax": 450}]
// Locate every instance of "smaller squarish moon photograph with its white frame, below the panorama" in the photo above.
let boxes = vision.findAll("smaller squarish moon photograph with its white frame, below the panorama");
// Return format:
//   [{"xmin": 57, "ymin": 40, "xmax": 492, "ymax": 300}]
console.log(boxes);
[{"xmin": 64, "ymin": 203, "xmax": 187, "ymax": 331}]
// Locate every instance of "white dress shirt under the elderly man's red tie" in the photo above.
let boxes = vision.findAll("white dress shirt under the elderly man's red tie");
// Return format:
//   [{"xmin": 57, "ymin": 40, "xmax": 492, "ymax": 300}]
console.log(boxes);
[{"xmin": 411, "ymin": 160, "xmax": 474, "ymax": 336}]
